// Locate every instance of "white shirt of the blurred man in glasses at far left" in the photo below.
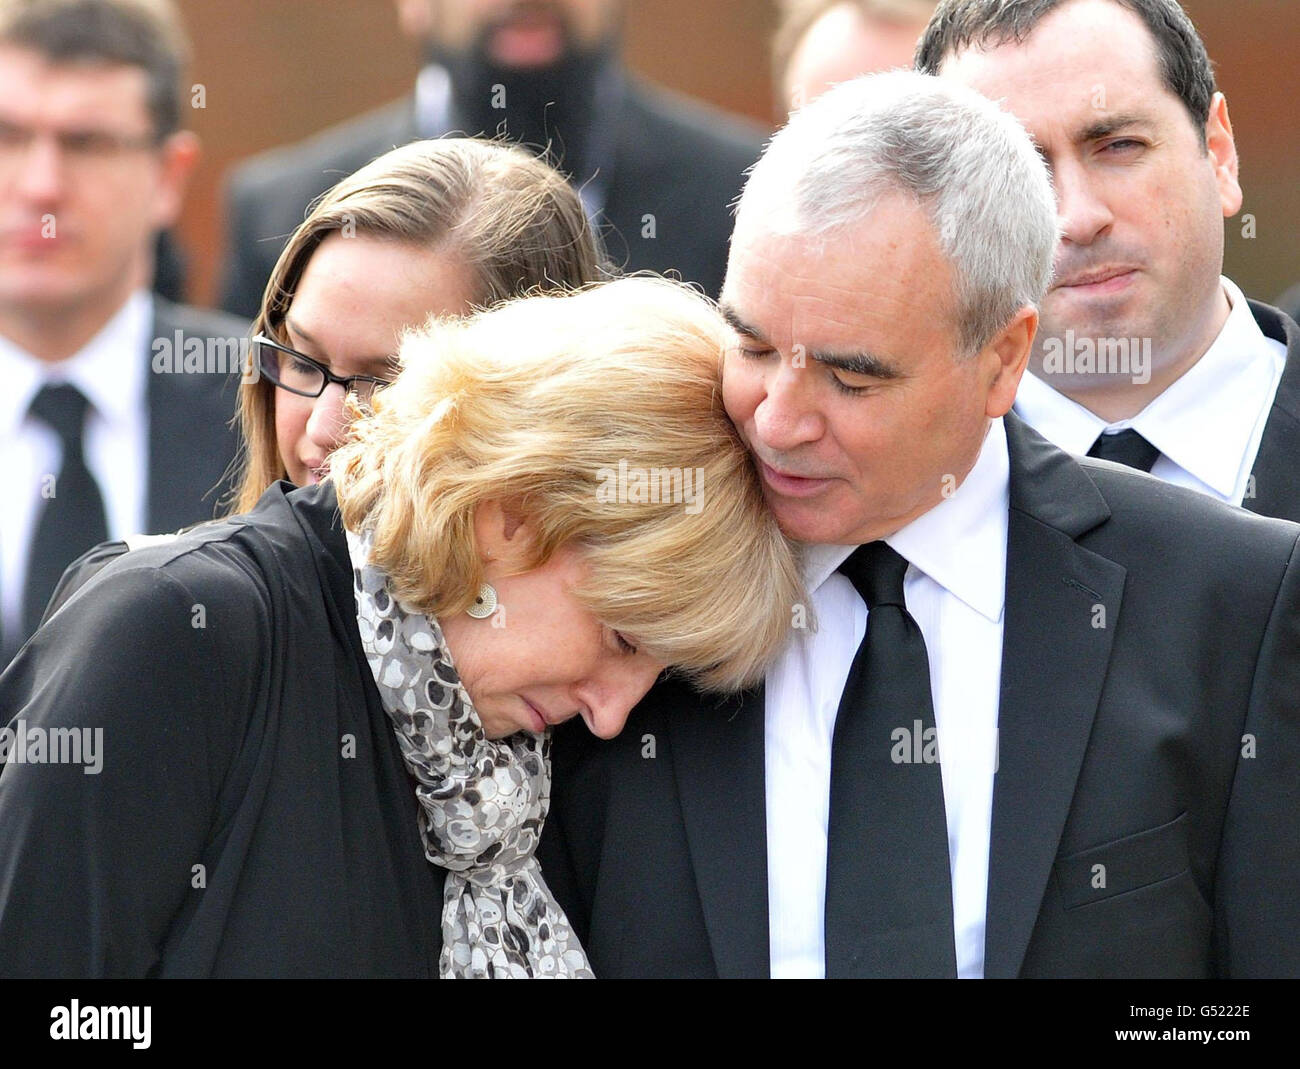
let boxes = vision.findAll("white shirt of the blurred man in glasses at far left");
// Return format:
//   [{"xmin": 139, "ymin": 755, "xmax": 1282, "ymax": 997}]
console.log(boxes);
[{"xmin": 0, "ymin": 290, "xmax": 153, "ymax": 645}]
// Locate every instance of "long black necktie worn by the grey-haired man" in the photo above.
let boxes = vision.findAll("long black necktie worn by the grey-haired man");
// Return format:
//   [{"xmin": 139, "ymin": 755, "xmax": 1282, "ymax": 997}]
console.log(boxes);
[{"xmin": 826, "ymin": 542, "xmax": 957, "ymax": 977}]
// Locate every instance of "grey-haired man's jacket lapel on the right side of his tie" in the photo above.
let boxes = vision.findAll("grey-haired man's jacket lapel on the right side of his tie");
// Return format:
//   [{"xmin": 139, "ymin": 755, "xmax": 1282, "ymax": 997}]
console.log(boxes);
[{"xmin": 984, "ymin": 416, "xmax": 1126, "ymax": 978}]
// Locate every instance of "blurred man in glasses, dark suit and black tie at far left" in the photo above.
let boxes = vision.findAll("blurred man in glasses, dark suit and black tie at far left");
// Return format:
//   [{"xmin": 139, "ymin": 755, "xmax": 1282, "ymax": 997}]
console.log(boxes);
[{"xmin": 0, "ymin": 0, "xmax": 246, "ymax": 666}]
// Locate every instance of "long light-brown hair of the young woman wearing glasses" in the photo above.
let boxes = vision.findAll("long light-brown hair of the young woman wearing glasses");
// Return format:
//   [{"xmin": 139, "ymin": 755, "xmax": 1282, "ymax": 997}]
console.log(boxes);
[{"xmin": 233, "ymin": 138, "xmax": 605, "ymax": 512}]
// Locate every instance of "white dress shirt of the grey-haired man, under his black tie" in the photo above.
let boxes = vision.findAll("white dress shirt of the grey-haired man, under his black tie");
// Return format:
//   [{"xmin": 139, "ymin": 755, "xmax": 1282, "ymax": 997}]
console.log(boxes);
[{"xmin": 764, "ymin": 420, "xmax": 1010, "ymax": 978}]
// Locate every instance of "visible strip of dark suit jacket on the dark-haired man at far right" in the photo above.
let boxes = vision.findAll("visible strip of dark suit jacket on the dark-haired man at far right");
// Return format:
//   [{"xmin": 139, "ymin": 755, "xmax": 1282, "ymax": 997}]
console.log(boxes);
[{"xmin": 1242, "ymin": 300, "xmax": 1300, "ymax": 521}]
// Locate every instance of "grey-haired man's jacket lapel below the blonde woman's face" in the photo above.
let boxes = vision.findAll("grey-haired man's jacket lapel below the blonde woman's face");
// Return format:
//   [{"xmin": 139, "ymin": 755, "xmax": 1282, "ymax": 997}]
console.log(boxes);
[{"xmin": 666, "ymin": 687, "xmax": 771, "ymax": 978}]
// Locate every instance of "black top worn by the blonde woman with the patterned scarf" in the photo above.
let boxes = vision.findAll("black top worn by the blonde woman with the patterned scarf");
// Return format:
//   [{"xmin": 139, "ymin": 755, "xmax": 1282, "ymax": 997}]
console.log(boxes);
[{"xmin": 0, "ymin": 482, "xmax": 443, "ymax": 978}]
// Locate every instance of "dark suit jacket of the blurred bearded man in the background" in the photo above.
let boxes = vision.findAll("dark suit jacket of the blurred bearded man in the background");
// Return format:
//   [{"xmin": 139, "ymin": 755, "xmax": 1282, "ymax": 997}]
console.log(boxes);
[{"xmin": 221, "ymin": 81, "xmax": 763, "ymax": 317}]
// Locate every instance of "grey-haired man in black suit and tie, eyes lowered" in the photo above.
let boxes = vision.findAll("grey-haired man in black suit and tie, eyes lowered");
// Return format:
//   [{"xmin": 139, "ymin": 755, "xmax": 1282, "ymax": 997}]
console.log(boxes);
[{"xmin": 542, "ymin": 73, "xmax": 1300, "ymax": 977}]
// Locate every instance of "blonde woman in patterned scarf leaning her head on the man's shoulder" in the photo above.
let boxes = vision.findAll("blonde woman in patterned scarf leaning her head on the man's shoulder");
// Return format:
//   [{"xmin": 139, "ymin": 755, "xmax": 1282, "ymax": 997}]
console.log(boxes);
[{"xmin": 0, "ymin": 278, "xmax": 800, "ymax": 977}]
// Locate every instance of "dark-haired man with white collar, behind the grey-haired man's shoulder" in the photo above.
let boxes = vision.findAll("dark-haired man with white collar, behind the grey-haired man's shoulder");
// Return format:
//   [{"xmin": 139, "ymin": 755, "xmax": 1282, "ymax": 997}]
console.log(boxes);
[{"xmin": 917, "ymin": 0, "xmax": 1300, "ymax": 520}]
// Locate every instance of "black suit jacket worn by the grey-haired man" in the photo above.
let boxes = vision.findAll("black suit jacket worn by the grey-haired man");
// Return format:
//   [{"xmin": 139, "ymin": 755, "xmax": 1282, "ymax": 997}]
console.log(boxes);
[{"xmin": 541, "ymin": 416, "xmax": 1300, "ymax": 977}]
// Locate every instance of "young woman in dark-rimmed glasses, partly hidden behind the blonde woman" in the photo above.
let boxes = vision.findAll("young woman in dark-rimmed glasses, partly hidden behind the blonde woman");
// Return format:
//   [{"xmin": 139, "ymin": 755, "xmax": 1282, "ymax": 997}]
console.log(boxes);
[{"xmin": 44, "ymin": 138, "xmax": 605, "ymax": 620}]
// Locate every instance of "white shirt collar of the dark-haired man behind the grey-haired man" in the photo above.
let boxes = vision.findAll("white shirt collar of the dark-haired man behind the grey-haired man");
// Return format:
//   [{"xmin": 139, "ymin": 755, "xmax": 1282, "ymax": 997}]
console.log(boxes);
[{"xmin": 1015, "ymin": 278, "xmax": 1287, "ymax": 505}]
